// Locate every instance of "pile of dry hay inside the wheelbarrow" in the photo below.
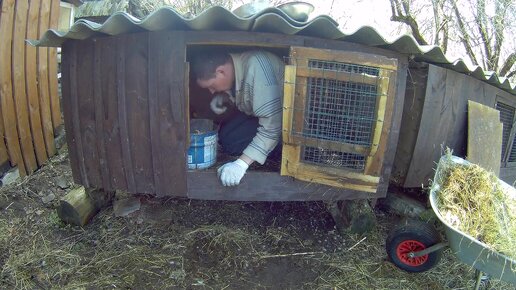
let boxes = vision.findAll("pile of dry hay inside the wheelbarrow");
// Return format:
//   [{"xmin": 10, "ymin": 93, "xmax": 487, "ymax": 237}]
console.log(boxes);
[{"xmin": 438, "ymin": 158, "xmax": 516, "ymax": 258}]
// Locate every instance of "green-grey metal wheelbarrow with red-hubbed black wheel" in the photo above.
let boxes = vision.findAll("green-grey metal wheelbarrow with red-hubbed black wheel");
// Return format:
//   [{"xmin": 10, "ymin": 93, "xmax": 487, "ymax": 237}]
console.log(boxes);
[{"xmin": 386, "ymin": 156, "xmax": 516, "ymax": 289}]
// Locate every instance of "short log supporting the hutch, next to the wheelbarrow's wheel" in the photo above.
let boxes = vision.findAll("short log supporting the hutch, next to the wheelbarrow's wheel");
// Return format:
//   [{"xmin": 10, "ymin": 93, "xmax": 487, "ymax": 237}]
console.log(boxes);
[{"xmin": 327, "ymin": 199, "xmax": 376, "ymax": 234}]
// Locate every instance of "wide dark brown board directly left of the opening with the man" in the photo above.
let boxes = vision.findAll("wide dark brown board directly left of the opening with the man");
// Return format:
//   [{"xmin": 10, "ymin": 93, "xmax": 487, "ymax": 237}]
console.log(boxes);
[{"xmin": 149, "ymin": 32, "xmax": 189, "ymax": 196}]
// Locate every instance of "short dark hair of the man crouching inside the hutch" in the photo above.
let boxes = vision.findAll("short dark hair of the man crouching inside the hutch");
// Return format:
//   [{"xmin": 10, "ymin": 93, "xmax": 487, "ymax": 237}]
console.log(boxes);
[{"xmin": 191, "ymin": 51, "xmax": 231, "ymax": 80}]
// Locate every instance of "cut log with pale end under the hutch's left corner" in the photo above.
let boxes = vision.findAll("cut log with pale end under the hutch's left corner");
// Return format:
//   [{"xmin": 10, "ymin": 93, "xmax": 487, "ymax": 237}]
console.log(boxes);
[{"xmin": 57, "ymin": 186, "xmax": 114, "ymax": 226}]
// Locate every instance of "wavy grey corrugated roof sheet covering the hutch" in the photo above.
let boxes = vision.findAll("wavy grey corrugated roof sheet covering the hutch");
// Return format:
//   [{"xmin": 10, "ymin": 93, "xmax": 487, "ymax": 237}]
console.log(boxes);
[{"xmin": 28, "ymin": 6, "xmax": 516, "ymax": 95}]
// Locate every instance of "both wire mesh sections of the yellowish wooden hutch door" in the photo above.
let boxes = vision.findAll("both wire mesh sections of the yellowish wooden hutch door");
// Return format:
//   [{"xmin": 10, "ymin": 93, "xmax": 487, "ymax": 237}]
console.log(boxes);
[{"xmin": 292, "ymin": 60, "xmax": 390, "ymax": 170}]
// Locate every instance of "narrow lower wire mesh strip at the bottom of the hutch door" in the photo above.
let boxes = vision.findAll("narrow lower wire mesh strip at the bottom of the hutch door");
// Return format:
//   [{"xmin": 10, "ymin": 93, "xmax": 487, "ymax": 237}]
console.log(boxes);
[{"xmin": 302, "ymin": 147, "xmax": 365, "ymax": 170}]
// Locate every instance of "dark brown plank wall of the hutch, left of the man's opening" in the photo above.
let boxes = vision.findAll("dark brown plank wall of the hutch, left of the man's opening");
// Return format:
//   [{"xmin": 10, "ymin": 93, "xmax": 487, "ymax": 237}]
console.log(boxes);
[{"xmin": 62, "ymin": 32, "xmax": 188, "ymax": 196}]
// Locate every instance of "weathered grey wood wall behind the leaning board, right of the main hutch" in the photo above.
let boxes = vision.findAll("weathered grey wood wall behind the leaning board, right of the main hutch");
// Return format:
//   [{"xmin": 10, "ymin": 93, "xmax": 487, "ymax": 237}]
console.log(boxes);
[{"xmin": 404, "ymin": 65, "xmax": 496, "ymax": 187}]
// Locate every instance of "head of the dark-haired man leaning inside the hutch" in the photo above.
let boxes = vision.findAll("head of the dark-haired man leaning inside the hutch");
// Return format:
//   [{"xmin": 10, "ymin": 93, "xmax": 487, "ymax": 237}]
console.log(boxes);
[{"xmin": 192, "ymin": 52, "xmax": 235, "ymax": 94}]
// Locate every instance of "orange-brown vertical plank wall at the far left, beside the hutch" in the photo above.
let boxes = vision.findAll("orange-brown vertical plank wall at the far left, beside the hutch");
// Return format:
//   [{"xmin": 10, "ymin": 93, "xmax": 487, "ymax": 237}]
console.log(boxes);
[{"xmin": 0, "ymin": 0, "xmax": 63, "ymax": 176}]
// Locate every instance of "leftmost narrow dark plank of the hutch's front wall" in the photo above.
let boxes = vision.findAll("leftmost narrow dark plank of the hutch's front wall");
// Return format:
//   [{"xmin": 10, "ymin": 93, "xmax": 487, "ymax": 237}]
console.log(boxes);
[{"xmin": 61, "ymin": 41, "xmax": 82, "ymax": 185}]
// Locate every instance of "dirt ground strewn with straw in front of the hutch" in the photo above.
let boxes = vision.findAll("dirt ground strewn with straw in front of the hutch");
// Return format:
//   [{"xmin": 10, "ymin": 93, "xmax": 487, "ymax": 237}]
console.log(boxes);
[{"xmin": 0, "ymin": 150, "xmax": 515, "ymax": 289}]
